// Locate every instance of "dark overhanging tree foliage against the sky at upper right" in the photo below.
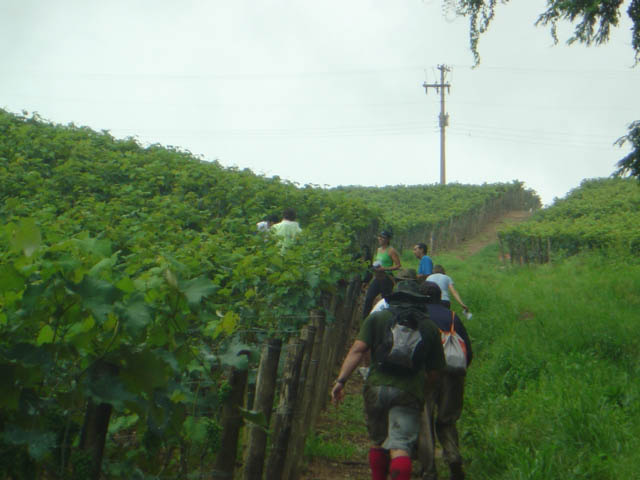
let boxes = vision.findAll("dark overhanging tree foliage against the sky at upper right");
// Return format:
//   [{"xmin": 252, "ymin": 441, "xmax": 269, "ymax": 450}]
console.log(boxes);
[{"xmin": 445, "ymin": 0, "xmax": 640, "ymax": 180}]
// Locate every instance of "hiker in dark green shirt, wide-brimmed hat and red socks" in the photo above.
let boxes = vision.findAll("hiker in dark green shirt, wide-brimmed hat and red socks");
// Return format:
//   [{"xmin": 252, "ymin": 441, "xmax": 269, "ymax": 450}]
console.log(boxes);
[{"xmin": 331, "ymin": 281, "xmax": 445, "ymax": 480}]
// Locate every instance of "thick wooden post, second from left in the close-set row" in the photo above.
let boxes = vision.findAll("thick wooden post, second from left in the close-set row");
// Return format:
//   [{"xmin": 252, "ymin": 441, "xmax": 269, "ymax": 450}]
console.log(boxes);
[{"xmin": 243, "ymin": 338, "xmax": 282, "ymax": 480}]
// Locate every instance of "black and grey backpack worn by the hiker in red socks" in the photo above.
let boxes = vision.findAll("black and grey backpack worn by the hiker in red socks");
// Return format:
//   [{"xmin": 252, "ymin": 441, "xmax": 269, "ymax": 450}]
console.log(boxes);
[{"xmin": 373, "ymin": 305, "xmax": 428, "ymax": 375}]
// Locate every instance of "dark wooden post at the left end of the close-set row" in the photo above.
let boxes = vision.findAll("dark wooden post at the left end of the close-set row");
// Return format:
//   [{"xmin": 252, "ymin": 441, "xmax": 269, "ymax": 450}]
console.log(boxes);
[{"xmin": 213, "ymin": 368, "xmax": 248, "ymax": 480}]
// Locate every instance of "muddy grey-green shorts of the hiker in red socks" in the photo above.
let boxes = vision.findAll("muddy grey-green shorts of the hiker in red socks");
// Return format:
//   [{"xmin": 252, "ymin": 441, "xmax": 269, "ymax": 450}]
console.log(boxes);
[{"xmin": 363, "ymin": 385, "xmax": 422, "ymax": 454}]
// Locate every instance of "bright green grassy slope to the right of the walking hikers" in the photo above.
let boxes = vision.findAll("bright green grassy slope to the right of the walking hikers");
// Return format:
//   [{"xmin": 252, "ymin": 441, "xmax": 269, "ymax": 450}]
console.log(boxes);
[{"xmin": 304, "ymin": 245, "xmax": 640, "ymax": 480}]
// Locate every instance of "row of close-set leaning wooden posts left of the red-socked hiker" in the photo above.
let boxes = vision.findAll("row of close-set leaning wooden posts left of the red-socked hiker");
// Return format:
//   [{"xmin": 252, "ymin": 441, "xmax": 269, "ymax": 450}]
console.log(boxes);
[{"xmin": 213, "ymin": 278, "xmax": 361, "ymax": 480}]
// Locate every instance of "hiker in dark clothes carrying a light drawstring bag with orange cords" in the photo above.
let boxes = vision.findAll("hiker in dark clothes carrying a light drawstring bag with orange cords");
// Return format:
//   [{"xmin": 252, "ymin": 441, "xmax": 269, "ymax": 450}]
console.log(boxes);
[{"xmin": 418, "ymin": 281, "xmax": 473, "ymax": 480}]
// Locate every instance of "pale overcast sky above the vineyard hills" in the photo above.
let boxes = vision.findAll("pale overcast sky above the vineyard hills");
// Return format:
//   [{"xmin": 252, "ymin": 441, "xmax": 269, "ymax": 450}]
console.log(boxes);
[{"xmin": 0, "ymin": 0, "xmax": 640, "ymax": 204}]
